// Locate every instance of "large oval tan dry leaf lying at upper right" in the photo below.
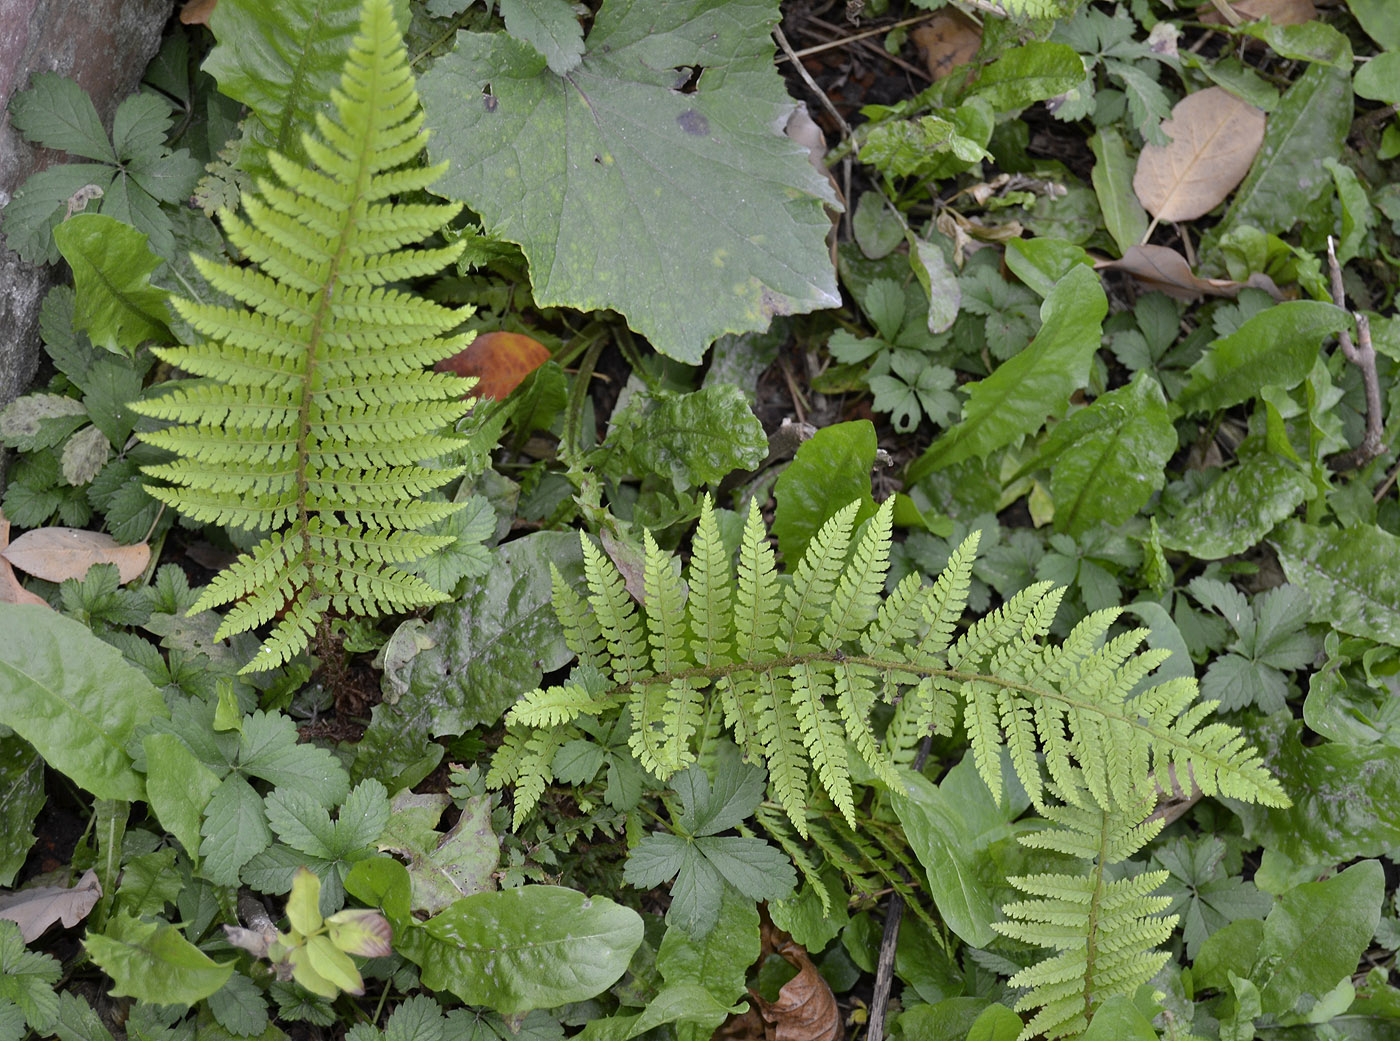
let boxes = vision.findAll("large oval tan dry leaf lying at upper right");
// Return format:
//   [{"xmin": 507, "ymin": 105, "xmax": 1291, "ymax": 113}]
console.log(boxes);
[{"xmin": 1133, "ymin": 87, "xmax": 1264, "ymax": 221}]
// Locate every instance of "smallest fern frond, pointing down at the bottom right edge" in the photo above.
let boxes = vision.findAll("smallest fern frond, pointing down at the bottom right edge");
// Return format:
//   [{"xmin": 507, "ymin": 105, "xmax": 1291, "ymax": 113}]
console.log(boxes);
[{"xmin": 993, "ymin": 788, "xmax": 1176, "ymax": 1041}]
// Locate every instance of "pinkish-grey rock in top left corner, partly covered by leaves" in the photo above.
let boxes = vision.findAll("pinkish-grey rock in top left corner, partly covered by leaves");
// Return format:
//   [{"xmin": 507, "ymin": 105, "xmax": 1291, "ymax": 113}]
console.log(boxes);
[{"xmin": 0, "ymin": 0, "xmax": 174, "ymax": 404}]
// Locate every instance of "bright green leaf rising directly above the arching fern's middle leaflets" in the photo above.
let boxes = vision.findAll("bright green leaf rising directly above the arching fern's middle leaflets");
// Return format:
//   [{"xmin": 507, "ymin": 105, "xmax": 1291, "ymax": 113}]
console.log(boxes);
[{"xmin": 773, "ymin": 420, "xmax": 876, "ymax": 561}]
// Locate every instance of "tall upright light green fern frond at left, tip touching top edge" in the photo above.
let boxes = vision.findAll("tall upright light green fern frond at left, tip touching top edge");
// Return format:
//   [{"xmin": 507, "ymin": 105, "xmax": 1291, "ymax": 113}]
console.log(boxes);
[{"xmin": 132, "ymin": 0, "xmax": 470, "ymax": 672}]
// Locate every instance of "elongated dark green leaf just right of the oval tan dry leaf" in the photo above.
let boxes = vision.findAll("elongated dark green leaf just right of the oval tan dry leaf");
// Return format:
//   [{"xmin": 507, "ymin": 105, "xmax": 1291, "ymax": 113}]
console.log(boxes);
[{"xmin": 1219, "ymin": 64, "xmax": 1351, "ymax": 234}]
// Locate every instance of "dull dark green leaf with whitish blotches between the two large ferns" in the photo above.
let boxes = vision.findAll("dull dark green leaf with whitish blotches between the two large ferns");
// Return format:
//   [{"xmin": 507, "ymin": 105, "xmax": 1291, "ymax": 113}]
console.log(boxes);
[{"xmin": 389, "ymin": 532, "xmax": 582, "ymax": 739}]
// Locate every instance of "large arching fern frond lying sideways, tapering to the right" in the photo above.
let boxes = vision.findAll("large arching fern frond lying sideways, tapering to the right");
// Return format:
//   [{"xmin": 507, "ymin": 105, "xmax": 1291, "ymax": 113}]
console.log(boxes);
[{"xmin": 490, "ymin": 501, "xmax": 1288, "ymax": 835}]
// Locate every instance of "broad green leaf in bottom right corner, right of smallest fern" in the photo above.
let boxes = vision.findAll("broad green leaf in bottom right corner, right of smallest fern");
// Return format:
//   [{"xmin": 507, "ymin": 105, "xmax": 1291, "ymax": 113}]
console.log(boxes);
[{"xmin": 1256, "ymin": 861, "xmax": 1386, "ymax": 1016}]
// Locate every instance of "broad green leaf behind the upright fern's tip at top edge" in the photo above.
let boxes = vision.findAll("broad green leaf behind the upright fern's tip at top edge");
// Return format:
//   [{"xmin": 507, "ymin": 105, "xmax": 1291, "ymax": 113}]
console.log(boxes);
[{"xmin": 204, "ymin": 0, "xmax": 409, "ymax": 176}]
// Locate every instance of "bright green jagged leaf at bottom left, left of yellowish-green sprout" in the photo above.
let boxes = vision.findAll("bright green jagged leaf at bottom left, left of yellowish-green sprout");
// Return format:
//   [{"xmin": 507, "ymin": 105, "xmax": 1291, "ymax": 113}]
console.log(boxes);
[{"xmin": 84, "ymin": 912, "xmax": 234, "ymax": 1005}]
